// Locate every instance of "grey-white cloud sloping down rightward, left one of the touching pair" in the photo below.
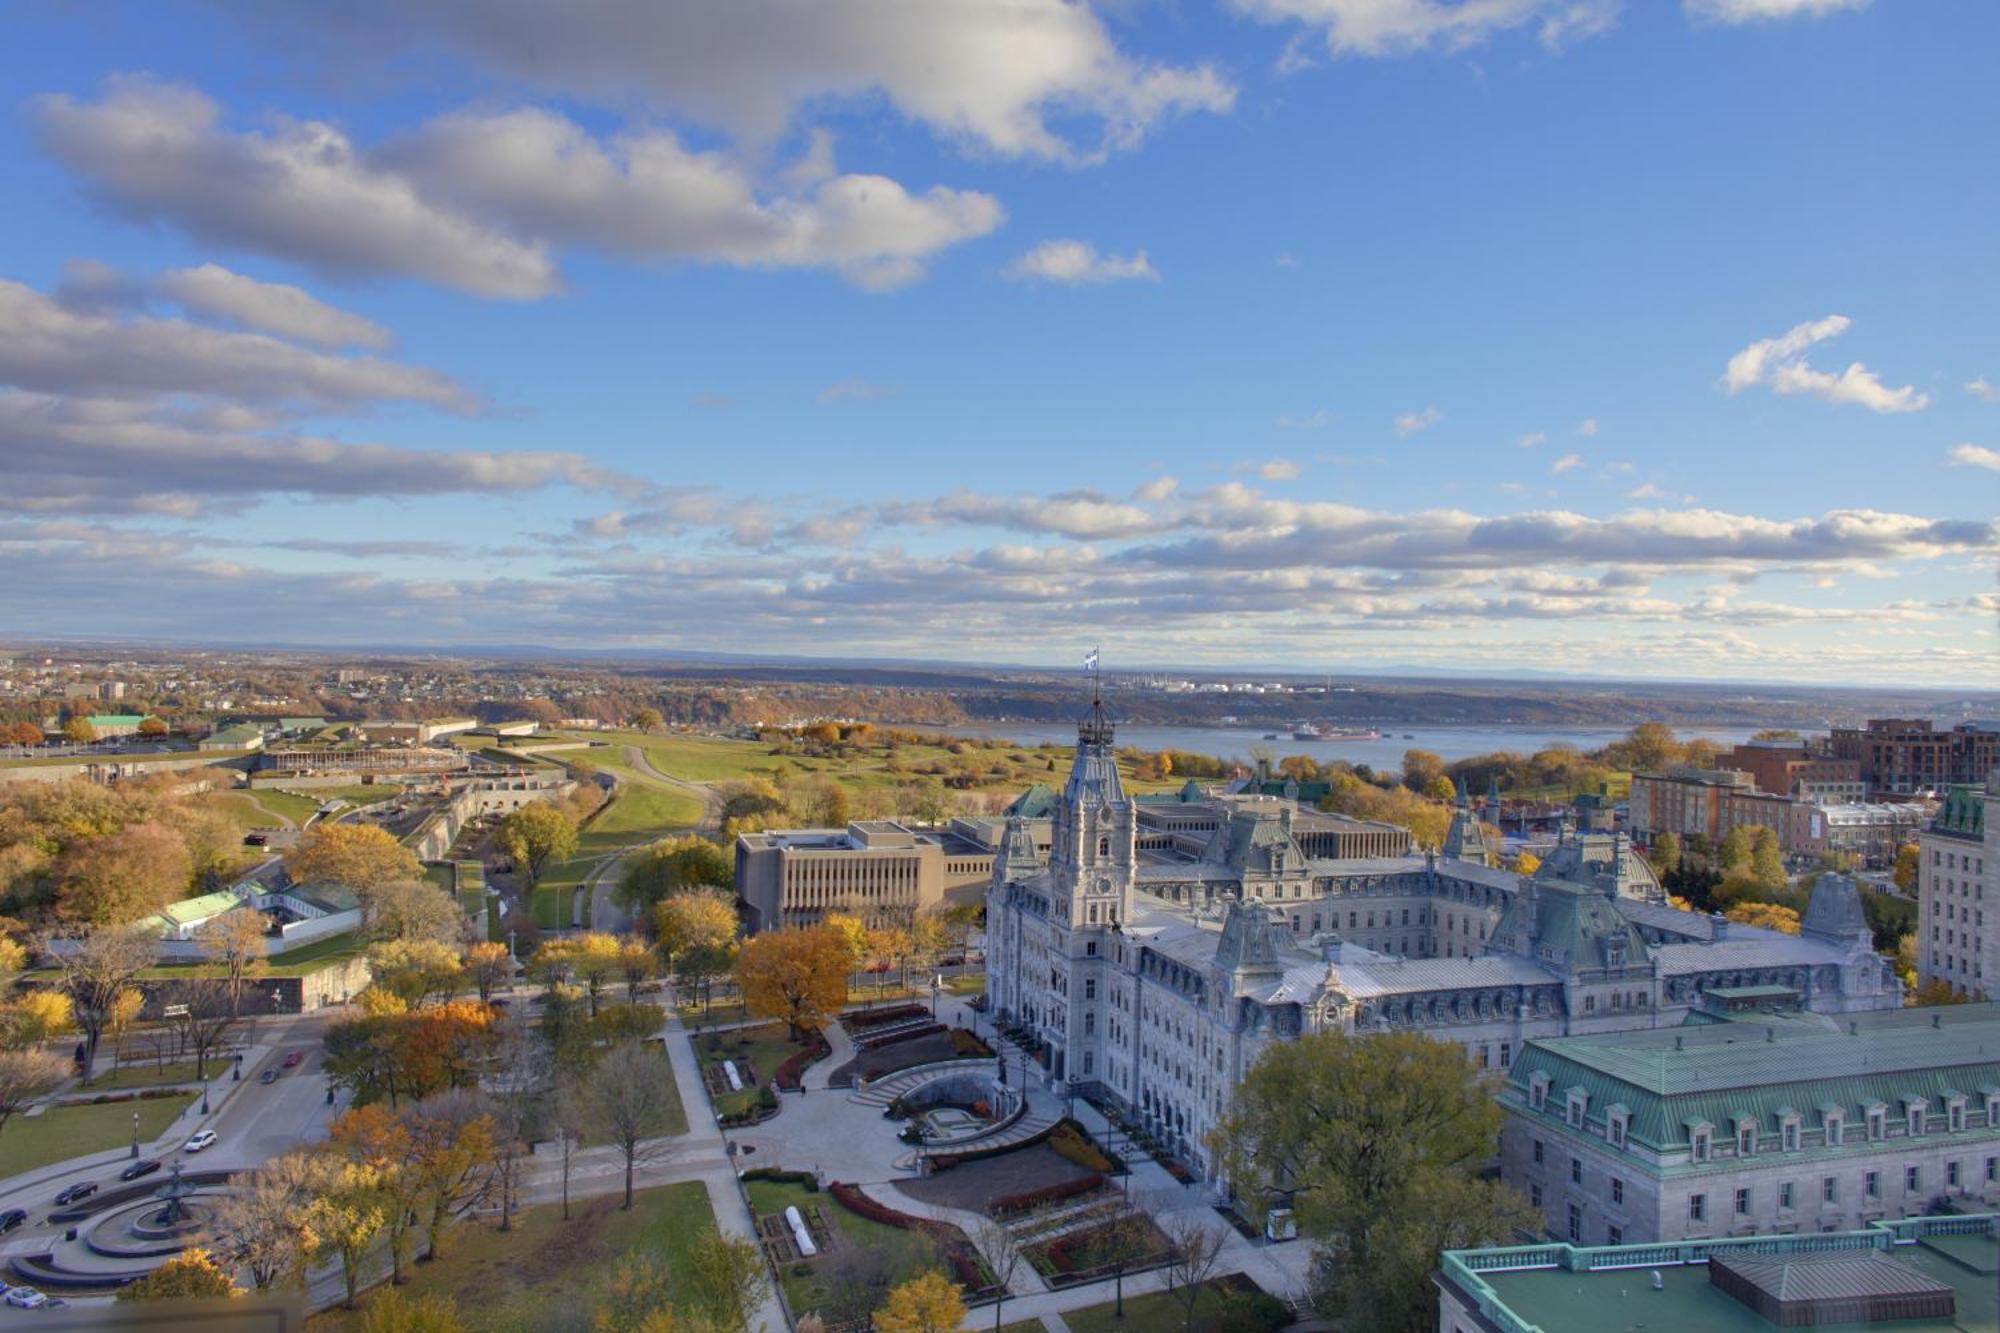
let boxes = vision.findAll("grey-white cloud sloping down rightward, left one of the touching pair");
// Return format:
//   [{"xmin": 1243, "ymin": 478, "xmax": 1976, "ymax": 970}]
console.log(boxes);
[{"xmin": 36, "ymin": 78, "xmax": 556, "ymax": 298}]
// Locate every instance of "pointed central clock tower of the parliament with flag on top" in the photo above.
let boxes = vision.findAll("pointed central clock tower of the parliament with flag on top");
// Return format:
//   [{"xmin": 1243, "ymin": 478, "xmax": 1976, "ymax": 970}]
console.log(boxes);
[{"xmin": 1048, "ymin": 654, "xmax": 1138, "ymax": 931}]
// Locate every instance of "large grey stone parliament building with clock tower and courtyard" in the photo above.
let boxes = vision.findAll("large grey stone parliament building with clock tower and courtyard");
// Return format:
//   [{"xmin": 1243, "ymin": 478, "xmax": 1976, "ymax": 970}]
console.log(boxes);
[{"xmin": 986, "ymin": 688, "xmax": 1902, "ymax": 1179}]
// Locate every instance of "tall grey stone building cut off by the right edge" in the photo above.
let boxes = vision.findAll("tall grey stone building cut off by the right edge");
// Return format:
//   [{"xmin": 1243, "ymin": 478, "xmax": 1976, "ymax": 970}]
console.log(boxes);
[{"xmin": 1916, "ymin": 771, "xmax": 2000, "ymax": 995}]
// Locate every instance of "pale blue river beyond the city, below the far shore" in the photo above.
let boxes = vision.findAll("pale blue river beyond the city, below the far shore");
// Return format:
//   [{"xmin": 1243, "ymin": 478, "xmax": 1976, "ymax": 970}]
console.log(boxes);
[{"xmin": 948, "ymin": 723, "xmax": 1756, "ymax": 773}]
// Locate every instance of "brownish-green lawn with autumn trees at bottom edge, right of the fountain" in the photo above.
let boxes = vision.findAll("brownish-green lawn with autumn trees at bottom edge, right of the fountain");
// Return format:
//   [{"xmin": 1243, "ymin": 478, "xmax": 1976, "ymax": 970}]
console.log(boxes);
[{"xmin": 306, "ymin": 1181, "xmax": 714, "ymax": 1333}]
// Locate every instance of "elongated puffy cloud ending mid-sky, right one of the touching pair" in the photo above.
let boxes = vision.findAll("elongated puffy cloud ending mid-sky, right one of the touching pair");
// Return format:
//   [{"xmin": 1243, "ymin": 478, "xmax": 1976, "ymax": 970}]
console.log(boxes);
[{"xmin": 378, "ymin": 108, "xmax": 1004, "ymax": 288}]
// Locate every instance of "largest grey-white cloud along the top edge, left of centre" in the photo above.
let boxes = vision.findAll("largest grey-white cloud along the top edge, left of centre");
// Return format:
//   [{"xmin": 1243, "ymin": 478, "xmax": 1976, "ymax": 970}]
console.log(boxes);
[{"xmin": 236, "ymin": 0, "xmax": 1236, "ymax": 162}]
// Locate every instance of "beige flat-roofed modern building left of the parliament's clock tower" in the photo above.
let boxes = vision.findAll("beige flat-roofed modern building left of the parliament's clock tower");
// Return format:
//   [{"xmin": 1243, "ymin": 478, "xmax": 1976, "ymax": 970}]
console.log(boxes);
[{"xmin": 736, "ymin": 819, "xmax": 994, "ymax": 931}]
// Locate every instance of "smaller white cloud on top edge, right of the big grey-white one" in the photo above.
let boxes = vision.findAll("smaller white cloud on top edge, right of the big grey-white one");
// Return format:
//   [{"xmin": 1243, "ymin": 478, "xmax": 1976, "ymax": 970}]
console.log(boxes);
[{"xmin": 1232, "ymin": 0, "xmax": 1620, "ymax": 58}]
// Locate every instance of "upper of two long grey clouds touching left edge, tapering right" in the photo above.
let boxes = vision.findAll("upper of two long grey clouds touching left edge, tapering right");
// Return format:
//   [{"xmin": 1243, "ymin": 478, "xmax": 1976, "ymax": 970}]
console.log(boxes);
[{"xmin": 0, "ymin": 278, "xmax": 478, "ymax": 412}]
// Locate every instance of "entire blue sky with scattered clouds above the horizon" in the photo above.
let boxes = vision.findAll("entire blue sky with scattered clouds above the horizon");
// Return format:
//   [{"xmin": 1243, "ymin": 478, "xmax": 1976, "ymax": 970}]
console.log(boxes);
[{"xmin": 0, "ymin": 0, "xmax": 2000, "ymax": 685}]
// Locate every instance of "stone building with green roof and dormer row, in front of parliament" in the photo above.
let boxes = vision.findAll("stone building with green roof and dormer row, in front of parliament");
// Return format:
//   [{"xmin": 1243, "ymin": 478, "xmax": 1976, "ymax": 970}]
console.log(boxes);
[{"xmin": 1500, "ymin": 1000, "xmax": 2000, "ymax": 1245}]
